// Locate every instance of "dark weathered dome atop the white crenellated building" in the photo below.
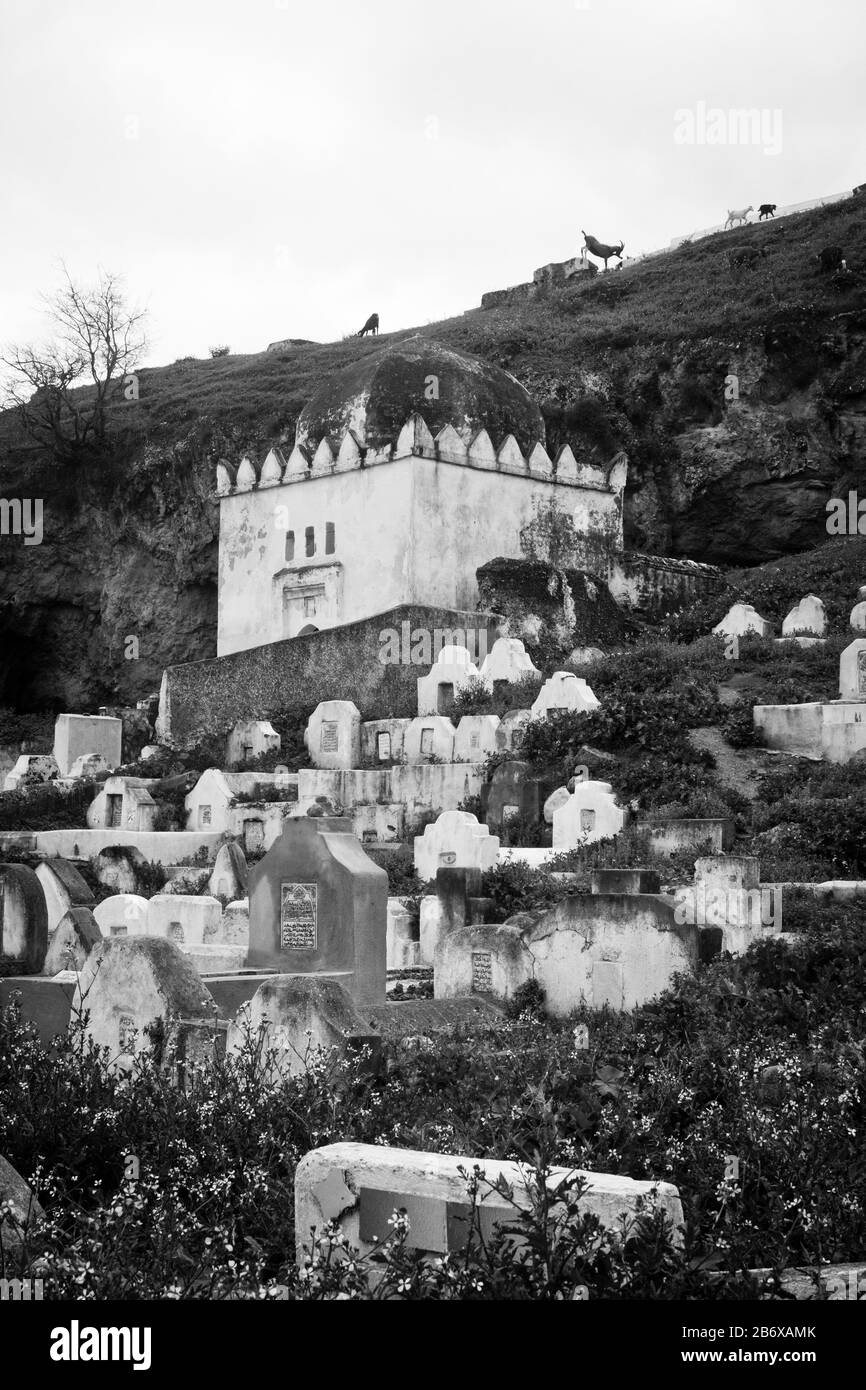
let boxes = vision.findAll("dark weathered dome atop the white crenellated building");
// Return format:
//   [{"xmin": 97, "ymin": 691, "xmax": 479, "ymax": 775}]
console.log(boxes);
[{"xmin": 297, "ymin": 334, "xmax": 545, "ymax": 452}]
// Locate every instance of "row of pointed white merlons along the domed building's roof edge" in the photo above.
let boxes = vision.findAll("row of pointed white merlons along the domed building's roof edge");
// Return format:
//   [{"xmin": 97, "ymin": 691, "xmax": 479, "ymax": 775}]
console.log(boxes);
[{"xmin": 215, "ymin": 414, "xmax": 628, "ymax": 498}]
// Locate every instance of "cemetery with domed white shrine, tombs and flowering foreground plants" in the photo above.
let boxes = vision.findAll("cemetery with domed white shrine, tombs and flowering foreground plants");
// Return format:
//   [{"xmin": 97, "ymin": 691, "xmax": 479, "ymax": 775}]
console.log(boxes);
[{"xmin": 0, "ymin": 252, "xmax": 866, "ymax": 1301}]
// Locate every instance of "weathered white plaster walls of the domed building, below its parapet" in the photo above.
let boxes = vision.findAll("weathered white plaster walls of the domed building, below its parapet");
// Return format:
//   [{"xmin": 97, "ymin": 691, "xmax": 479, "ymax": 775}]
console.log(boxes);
[{"xmin": 217, "ymin": 456, "xmax": 623, "ymax": 656}]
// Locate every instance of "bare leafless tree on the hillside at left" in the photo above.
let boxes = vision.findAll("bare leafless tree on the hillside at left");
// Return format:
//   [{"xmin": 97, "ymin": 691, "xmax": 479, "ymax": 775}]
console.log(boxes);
[{"xmin": 0, "ymin": 265, "xmax": 147, "ymax": 461}]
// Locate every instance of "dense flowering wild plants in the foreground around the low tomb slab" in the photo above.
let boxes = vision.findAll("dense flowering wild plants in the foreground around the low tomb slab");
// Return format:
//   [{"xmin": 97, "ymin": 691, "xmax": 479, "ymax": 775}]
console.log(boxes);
[{"xmin": 0, "ymin": 899, "xmax": 866, "ymax": 1300}]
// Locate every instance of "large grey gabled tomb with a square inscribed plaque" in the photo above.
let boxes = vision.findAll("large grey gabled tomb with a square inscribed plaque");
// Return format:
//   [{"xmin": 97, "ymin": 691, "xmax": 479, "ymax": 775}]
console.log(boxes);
[{"xmin": 247, "ymin": 816, "xmax": 388, "ymax": 1004}]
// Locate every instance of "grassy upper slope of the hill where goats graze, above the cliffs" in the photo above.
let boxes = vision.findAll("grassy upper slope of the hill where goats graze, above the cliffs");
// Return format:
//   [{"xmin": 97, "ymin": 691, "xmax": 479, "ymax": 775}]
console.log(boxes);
[{"xmin": 0, "ymin": 197, "xmax": 866, "ymax": 467}]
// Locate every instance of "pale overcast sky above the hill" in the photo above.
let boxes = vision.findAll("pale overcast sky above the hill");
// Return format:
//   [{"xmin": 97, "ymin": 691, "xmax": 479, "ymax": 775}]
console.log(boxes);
[{"xmin": 0, "ymin": 0, "xmax": 866, "ymax": 366}]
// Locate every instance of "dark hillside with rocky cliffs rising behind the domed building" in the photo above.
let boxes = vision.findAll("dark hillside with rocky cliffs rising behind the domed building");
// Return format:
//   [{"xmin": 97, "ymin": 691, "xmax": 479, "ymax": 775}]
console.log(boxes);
[{"xmin": 0, "ymin": 197, "xmax": 866, "ymax": 709}]
